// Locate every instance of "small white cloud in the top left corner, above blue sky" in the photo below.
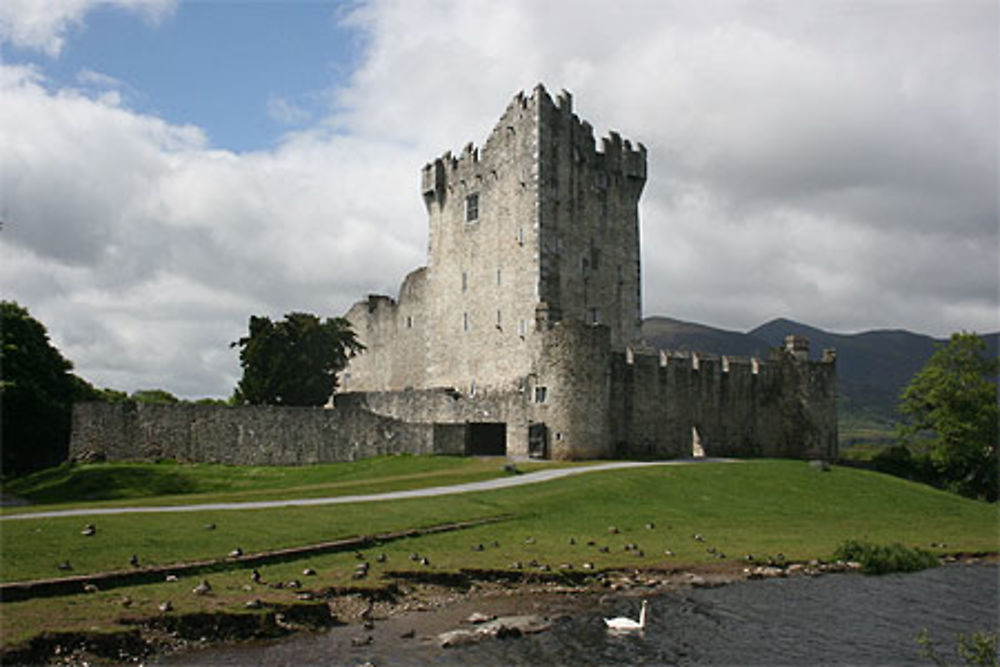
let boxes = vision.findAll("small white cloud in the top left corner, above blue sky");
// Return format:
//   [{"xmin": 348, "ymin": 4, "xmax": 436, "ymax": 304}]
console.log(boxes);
[{"xmin": 0, "ymin": 0, "xmax": 177, "ymax": 57}]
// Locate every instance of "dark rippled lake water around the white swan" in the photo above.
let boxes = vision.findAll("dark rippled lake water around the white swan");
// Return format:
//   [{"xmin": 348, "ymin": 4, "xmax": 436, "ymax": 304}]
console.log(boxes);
[{"xmin": 162, "ymin": 563, "xmax": 1000, "ymax": 666}]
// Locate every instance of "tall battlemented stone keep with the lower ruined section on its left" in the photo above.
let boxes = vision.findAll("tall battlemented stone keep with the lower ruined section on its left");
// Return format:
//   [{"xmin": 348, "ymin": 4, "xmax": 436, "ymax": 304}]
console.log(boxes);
[{"xmin": 347, "ymin": 85, "xmax": 646, "ymax": 391}]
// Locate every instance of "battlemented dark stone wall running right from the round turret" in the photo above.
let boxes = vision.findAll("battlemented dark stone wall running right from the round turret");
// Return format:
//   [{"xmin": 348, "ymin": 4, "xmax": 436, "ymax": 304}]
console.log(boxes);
[{"xmin": 610, "ymin": 351, "xmax": 837, "ymax": 459}]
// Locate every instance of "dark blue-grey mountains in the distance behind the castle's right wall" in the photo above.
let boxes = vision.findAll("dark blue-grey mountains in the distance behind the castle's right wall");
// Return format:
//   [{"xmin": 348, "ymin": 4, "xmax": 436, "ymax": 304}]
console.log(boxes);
[{"xmin": 642, "ymin": 317, "xmax": 1000, "ymax": 434}]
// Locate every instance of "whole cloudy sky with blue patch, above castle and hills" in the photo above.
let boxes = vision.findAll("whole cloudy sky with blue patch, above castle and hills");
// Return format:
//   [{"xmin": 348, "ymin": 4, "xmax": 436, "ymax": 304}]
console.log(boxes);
[{"xmin": 0, "ymin": 0, "xmax": 1000, "ymax": 398}]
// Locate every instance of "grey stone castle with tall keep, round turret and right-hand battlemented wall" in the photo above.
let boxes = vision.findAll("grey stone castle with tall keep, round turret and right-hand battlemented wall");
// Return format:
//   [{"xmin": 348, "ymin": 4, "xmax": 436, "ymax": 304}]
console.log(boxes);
[{"xmin": 334, "ymin": 85, "xmax": 837, "ymax": 459}]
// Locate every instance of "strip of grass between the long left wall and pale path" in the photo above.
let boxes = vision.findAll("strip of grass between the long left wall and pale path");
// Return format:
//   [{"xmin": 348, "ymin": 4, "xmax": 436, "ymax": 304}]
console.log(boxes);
[{"xmin": 3, "ymin": 455, "xmax": 569, "ymax": 513}]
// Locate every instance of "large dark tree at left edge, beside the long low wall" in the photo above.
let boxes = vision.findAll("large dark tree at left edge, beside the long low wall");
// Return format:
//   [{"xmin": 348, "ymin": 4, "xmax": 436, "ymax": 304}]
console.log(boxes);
[{"xmin": 0, "ymin": 301, "xmax": 100, "ymax": 476}]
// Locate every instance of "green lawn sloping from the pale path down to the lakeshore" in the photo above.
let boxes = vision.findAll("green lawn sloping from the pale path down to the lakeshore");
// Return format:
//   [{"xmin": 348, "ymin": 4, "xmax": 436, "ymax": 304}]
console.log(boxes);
[{"xmin": 0, "ymin": 459, "xmax": 1000, "ymax": 644}]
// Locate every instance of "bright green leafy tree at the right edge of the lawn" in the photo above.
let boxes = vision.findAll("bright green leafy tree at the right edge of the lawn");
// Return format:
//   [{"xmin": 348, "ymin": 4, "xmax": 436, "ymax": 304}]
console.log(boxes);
[{"xmin": 899, "ymin": 332, "xmax": 1000, "ymax": 501}]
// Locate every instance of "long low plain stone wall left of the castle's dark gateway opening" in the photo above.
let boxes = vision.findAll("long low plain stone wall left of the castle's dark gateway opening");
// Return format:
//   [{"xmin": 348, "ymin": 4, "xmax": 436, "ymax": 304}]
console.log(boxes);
[{"xmin": 70, "ymin": 403, "xmax": 437, "ymax": 465}]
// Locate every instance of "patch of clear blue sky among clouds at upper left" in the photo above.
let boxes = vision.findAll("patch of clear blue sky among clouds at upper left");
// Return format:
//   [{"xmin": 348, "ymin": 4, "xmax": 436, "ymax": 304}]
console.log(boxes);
[{"xmin": 7, "ymin": 0, "xmax": 363, "ymax": 151}]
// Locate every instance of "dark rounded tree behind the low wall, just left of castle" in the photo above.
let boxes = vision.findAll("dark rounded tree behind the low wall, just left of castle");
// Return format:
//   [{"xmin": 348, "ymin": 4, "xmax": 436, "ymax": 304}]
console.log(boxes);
[{"xmin": 230, "ymin": 313, "xmax": 364, "ymax": 405}]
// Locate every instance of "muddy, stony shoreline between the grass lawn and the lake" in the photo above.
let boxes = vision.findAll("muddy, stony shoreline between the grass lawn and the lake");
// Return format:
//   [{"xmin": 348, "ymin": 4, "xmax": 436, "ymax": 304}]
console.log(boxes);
[{"xmin": 0, "ymin": 554, "xmax": 997, "ymax": 665}]
